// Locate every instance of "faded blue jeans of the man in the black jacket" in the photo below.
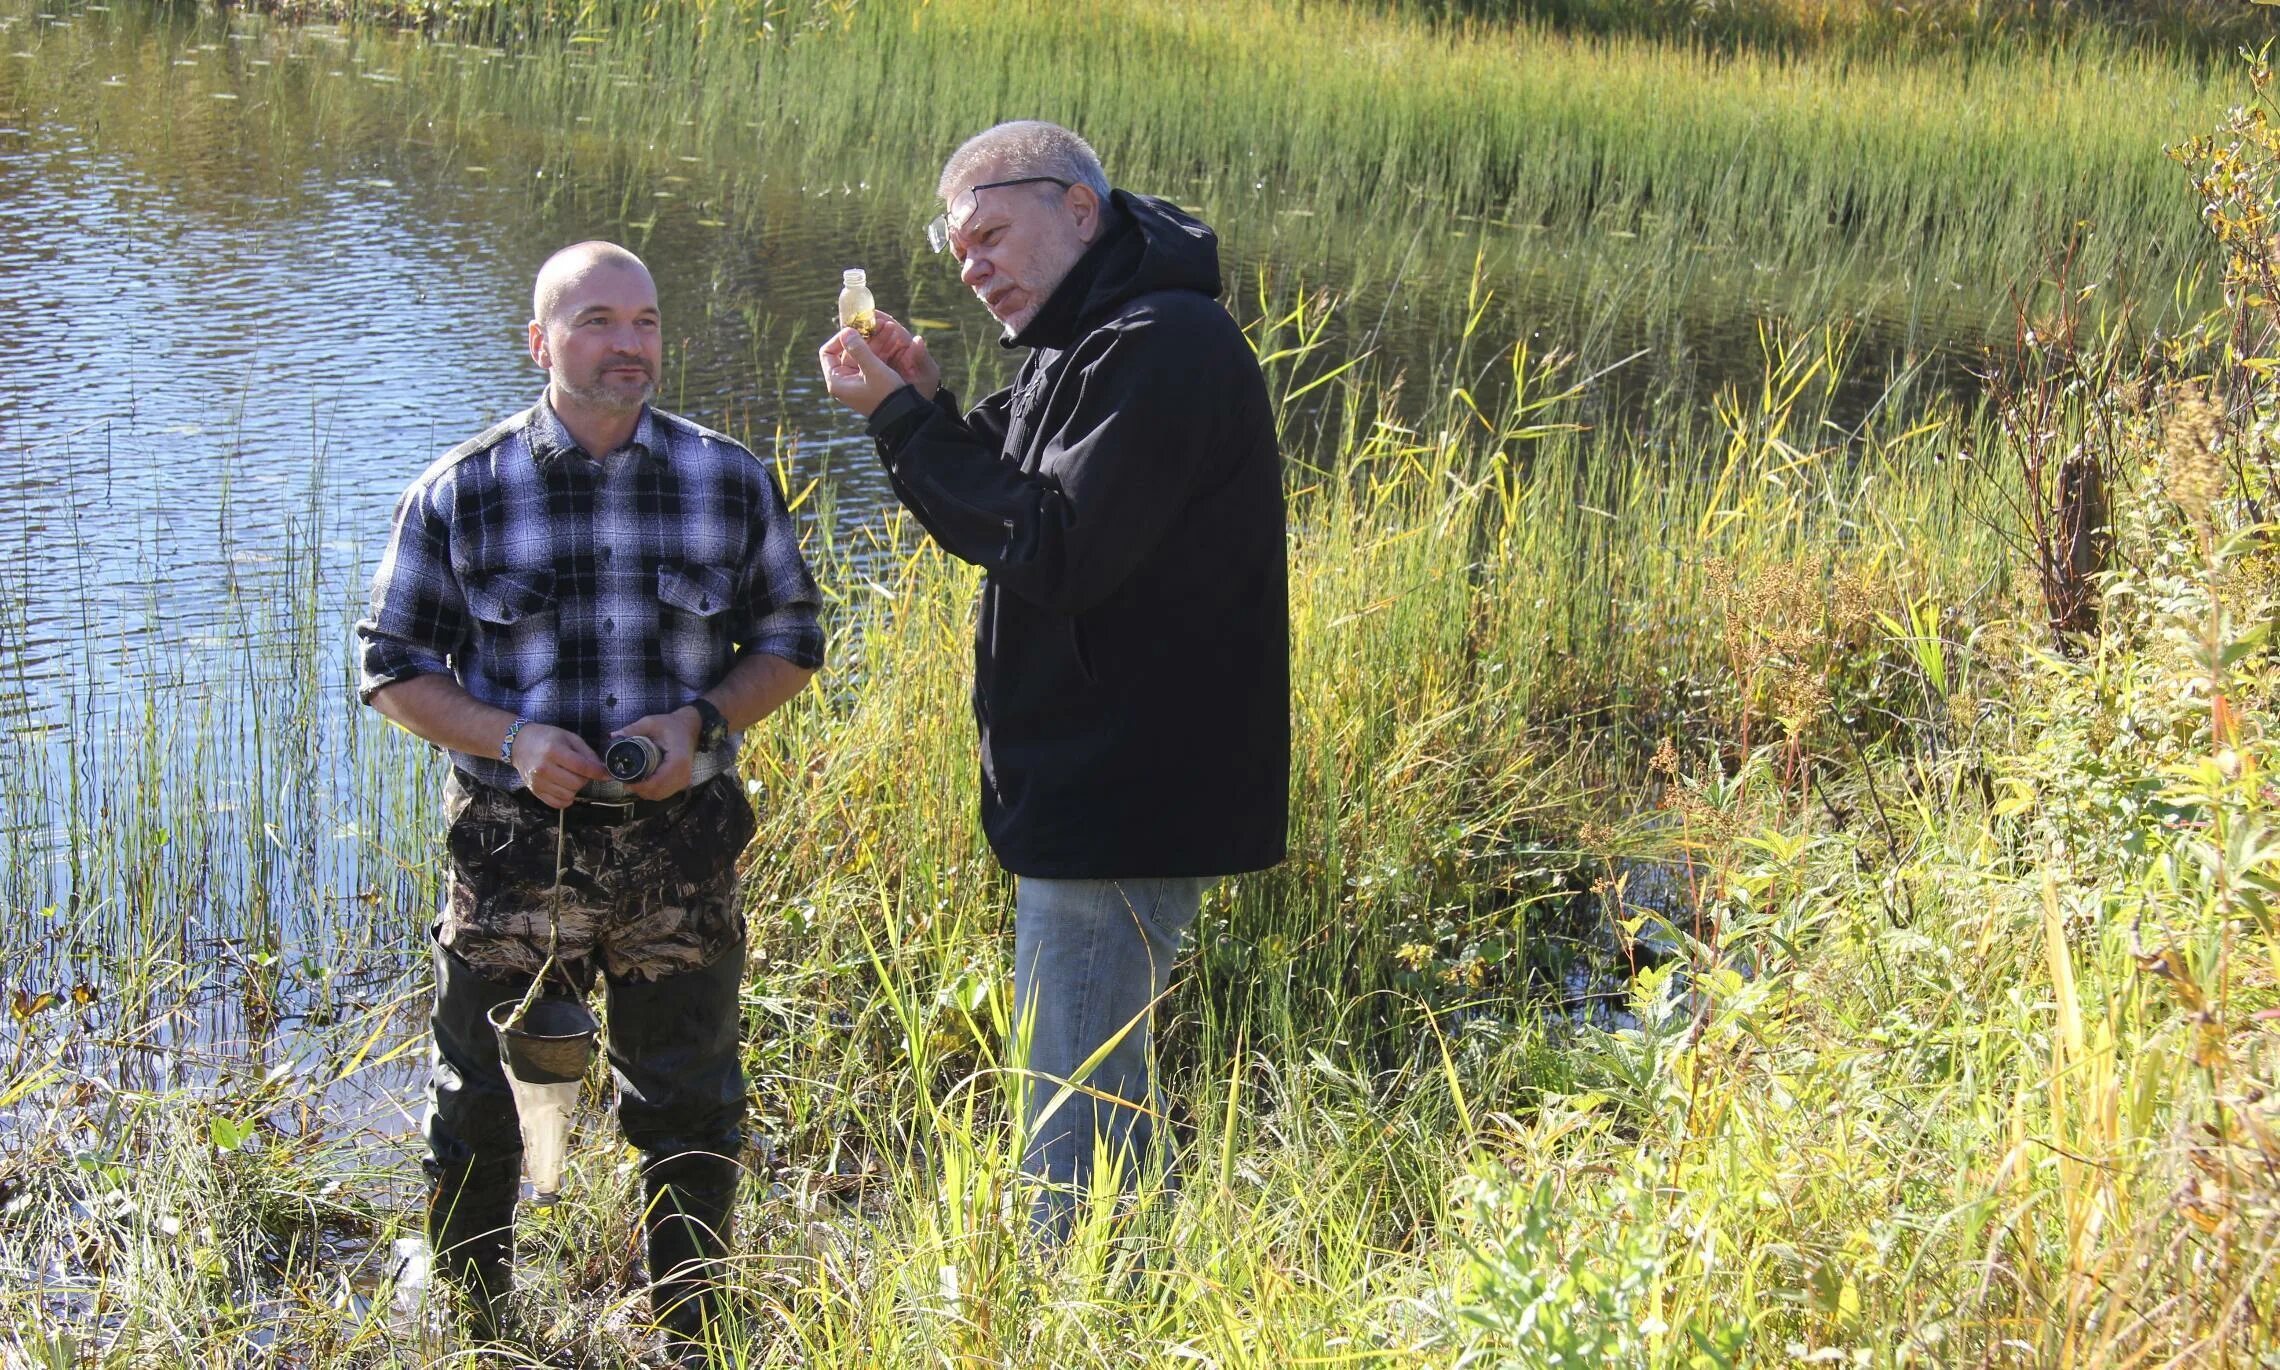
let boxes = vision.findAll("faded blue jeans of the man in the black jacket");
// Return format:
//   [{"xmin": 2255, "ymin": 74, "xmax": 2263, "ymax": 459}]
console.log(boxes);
[{"xmin": 1012, "ymin": 875, "xmax": 1211, "ymax": 1236}]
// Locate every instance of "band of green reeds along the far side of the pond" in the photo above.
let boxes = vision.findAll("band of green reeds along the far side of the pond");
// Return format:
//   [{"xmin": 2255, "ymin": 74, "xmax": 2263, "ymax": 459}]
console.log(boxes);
[{"xmin": 62, "ymin": 0, "xmax": 2223, "ymax": 337}]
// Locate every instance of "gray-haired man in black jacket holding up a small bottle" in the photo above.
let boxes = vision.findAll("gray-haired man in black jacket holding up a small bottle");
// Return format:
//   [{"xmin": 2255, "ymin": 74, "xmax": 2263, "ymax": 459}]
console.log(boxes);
[{"xmin": 821, "ymin": 121, "xmax": 1290, "ymax": 1233}]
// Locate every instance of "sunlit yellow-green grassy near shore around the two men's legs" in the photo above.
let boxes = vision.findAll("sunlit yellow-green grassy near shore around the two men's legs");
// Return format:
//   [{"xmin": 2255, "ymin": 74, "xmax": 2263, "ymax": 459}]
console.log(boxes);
[{"xmin": 0, "ymin": 5, "xmax": 2280, "ymax": 1368}]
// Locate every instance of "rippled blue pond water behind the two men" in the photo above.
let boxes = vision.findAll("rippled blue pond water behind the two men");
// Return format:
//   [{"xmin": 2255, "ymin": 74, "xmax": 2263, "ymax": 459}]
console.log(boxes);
[{"xmin": 0, "ymin": 0, "xmax": 2033, "ymax": 1126}]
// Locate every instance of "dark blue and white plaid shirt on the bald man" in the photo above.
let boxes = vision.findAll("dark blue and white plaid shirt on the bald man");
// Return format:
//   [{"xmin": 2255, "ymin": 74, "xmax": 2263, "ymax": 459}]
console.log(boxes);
[{"xmin": 356, "ymin": 397, "xmax": 823, "ymax": 789}]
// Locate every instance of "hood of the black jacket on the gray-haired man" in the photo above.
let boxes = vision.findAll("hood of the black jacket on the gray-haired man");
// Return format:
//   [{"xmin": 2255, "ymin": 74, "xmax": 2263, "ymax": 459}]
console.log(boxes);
[{"xmin": 999, "ymin": 189, "xmax": 1220, "ymax": 346}]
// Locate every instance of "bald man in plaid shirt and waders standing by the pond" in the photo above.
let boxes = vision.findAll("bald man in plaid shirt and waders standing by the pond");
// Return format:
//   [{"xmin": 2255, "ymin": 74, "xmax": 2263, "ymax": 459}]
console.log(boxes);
[{"xmin": 356, "ymin": 242, "xmax": 823, "ymax": 1363}]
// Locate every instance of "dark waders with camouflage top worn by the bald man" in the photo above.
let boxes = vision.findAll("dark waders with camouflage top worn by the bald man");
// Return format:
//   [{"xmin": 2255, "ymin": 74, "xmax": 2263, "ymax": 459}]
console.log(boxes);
[{"xmin": 426, "ymin": 770, "xmax": 755, "ymax": 1354}]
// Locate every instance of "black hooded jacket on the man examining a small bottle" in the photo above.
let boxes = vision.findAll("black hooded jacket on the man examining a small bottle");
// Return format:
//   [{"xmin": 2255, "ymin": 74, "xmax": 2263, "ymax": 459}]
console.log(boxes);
[{"xmin": 871, "ymin": 191, "xmax": 1290, "ymax": 880}]
